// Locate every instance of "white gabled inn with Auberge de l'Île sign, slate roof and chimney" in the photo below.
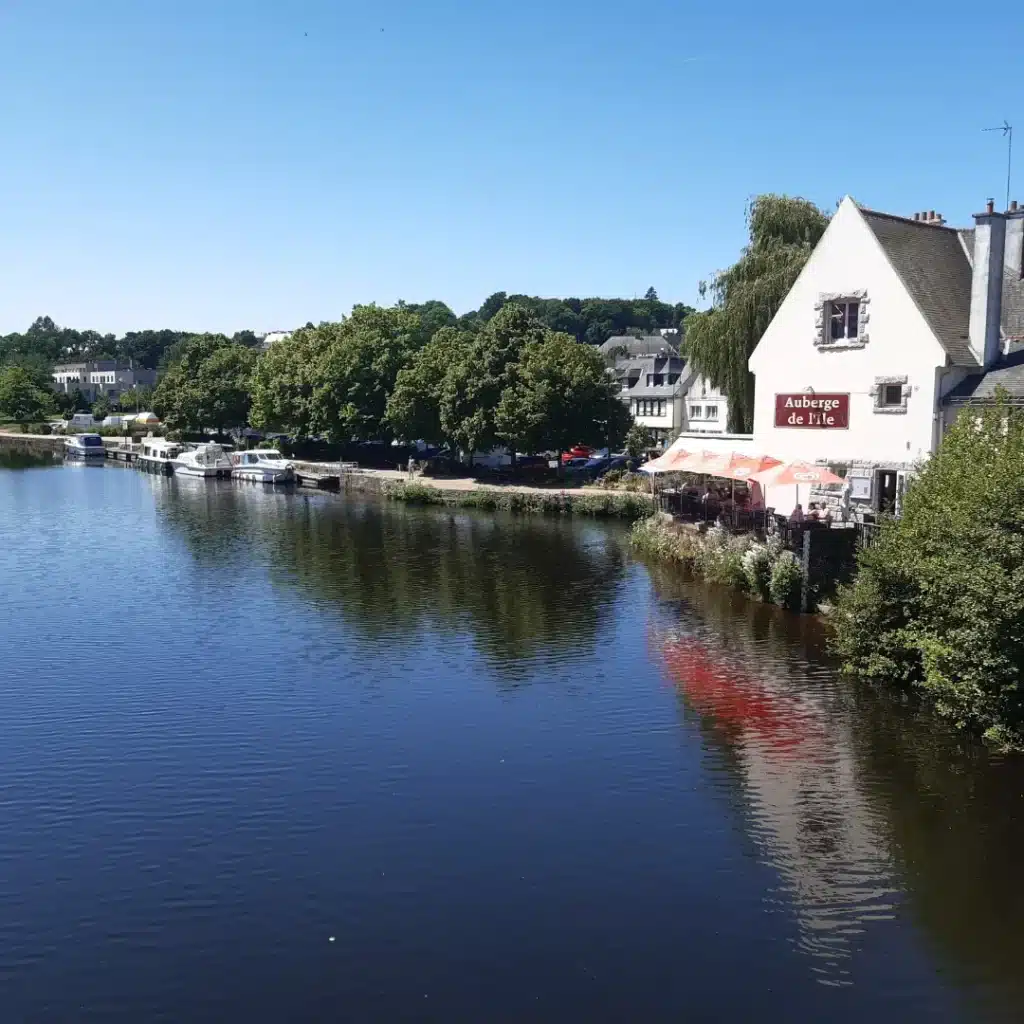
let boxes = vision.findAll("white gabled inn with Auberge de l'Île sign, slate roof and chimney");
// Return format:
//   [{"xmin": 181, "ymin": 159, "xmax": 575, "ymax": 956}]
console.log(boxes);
[{"xmin": 745, "ymin": 197, "xmax": 1024, "ymax": 508}]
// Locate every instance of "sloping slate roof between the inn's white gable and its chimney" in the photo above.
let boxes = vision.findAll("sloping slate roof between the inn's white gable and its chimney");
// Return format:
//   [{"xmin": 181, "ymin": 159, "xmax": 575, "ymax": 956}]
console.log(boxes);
[{"xmin": 860, "ymin": 209, "xmax": 978, "ymax": 367}]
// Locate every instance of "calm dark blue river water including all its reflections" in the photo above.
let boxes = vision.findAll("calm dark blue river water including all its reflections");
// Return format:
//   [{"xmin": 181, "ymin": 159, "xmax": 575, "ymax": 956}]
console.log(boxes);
[{"xmin": 0, "ymin": 466, "xmax": 1024, "ymax": 1024}]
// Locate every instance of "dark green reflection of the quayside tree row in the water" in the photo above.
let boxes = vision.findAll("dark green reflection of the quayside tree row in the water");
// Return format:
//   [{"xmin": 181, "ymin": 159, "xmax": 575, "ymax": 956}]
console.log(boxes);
[{"xmin": 148, "ymin": 476, "xmax": 626, "ymax": 678}]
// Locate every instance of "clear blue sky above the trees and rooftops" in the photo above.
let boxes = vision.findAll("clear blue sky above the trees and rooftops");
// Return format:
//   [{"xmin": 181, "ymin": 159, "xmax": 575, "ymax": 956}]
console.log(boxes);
[{"xmin": 0, "ymin": 0, "xmax": 1024, "ymax": 333}]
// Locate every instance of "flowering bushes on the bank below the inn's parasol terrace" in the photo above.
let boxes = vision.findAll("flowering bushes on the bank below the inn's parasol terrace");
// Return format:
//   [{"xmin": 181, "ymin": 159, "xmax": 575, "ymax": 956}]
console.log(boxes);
[{"xmin": 632, "ymin": 515, "xmax": 804, "ymax": 611}]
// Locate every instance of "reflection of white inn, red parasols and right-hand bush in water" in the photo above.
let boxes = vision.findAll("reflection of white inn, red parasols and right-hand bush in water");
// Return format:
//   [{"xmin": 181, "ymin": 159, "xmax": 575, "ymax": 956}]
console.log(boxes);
[{"xmin": 650, "ymin": 573, "xmax": 1024, "ymax": 1016}]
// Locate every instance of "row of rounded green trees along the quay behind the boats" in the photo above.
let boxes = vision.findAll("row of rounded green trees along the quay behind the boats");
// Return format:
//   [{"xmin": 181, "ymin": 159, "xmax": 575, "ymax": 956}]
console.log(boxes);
[{"xmin": 153, "ymin": 302, "xmax": 632, "ymax": 453}]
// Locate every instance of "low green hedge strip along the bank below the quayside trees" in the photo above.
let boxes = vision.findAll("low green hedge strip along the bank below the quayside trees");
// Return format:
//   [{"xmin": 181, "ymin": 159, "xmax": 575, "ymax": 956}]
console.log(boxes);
[{"xmin": 381, "ymin": 481, "xmax": 653, "ymax": 520}]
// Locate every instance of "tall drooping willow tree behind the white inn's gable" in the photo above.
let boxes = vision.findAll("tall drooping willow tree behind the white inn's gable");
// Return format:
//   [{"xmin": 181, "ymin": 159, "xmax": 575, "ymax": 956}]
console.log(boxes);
[{"xmin": 686, "ymin": 195, "xmax": 828, "ymax": 433}]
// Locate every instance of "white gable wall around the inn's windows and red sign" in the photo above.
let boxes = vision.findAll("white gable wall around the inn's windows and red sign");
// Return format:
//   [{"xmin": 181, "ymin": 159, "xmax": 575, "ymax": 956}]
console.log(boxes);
[{"xmin": 750, "ymin": 198, "xmax": 946, "ymax": 463}]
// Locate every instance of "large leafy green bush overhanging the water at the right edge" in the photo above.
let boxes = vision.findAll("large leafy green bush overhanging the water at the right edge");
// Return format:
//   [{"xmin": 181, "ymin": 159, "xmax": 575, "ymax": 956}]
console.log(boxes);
[{"xmin": 836, "ymin": 396, "xmax": 1024, "ymax": 745}]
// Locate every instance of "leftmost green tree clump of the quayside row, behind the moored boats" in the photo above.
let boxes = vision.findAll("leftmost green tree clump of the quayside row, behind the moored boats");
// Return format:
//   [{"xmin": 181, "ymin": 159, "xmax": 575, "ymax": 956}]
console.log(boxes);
[{"xmin": 153, "ymin": 334, "xmax": 257, "ymax": 430}]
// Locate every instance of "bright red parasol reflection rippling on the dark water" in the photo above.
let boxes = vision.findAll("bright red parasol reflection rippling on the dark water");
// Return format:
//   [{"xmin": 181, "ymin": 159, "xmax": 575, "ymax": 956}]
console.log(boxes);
[{"xmin": 662, "ymin": 637, "xmax": 824, "ymax": 760}]
